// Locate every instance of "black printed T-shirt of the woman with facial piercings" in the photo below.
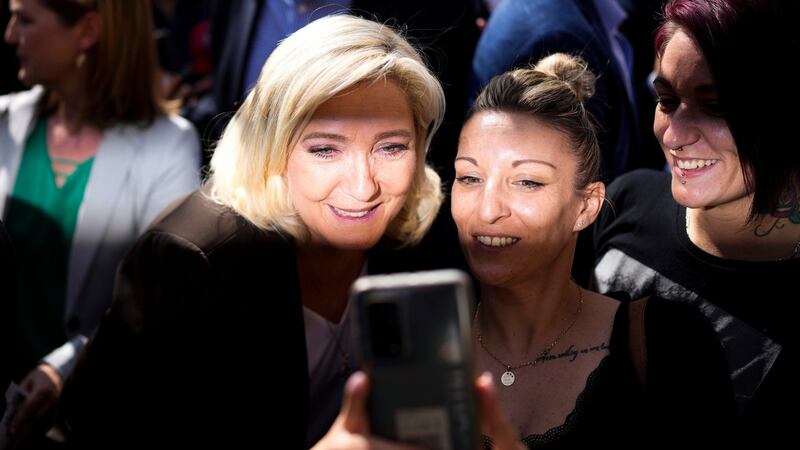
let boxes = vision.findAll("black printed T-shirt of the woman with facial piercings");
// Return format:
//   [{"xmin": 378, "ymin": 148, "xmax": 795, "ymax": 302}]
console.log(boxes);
[{"xmin": 595, "ymin": 170, "xmax": 800, "ymax": 444}]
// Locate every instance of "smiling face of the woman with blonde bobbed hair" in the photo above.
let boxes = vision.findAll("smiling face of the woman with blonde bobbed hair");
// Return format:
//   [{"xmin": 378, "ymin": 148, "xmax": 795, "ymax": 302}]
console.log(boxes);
[{"xmin": 286, "ymin": 81, "xmax": 418, "ymax": 250}]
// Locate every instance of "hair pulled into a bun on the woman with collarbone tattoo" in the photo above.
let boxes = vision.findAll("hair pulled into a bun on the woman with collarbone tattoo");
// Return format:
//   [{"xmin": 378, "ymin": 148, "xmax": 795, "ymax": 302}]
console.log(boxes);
[{"xmin": 468, "ymin": 53, "xmax": 600, "ymax": 190}]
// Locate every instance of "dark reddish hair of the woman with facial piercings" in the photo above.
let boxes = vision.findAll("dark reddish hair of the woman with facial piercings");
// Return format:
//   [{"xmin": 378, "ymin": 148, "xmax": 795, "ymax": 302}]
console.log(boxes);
[{"xmin": 655, "ymin": 0, "xmax": 800, "ymax": 221}]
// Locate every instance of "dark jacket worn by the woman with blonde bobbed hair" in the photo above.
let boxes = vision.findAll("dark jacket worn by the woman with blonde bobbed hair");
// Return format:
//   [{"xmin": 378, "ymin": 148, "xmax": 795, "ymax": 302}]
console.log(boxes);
[{"xmin": 63, "ymin": 192, "xmax": 309, "ymax": 448}]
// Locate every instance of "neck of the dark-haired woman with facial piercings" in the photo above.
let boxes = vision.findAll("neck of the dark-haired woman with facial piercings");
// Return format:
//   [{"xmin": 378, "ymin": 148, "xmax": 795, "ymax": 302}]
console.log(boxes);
[{"xmin": 686, "ymin": 196, "xmax": 800, "ymax": 261}]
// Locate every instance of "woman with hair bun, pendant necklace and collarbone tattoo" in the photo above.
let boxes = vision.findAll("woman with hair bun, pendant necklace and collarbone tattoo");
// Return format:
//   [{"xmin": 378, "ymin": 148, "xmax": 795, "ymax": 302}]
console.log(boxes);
[{"xmin": 452, "ymin": 54, "xmax": 733, "ymax": 448}]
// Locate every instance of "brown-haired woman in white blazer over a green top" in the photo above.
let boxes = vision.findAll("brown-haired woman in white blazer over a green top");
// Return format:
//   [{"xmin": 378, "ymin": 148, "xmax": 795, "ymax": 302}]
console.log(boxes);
[{"xmin": 0, "ymin": 0, "xmax": 201, "ymax": 442}]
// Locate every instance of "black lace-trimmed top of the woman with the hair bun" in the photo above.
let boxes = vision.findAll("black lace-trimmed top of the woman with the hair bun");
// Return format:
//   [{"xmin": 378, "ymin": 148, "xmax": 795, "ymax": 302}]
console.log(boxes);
[{"xmin": 484, "ymin": 294, "xmax": 735, "ymax": 449}]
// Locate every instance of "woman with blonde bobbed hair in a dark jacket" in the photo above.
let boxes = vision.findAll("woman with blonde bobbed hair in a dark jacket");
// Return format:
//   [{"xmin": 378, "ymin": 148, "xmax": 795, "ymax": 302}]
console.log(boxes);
[{"xmin": 65, "ymin": 16, "xmax": 444, "ymax": 448}]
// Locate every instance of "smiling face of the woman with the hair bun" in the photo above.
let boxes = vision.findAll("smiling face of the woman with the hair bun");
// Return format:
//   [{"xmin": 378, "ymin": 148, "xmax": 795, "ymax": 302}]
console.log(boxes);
[{"xmin": 451, "ymin": 112, "xmax": 582, "ymax": 286}]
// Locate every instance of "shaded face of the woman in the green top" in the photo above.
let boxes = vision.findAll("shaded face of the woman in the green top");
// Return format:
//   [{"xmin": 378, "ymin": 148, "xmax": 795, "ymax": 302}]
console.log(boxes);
[{"xmin": 5, "ymin": 0, "xmax": 80, "ymax": 86}]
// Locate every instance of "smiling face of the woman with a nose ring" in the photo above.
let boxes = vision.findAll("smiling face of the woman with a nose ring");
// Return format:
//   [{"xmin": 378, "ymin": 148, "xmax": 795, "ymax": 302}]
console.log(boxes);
[{"xmin": 653, "ymin": 29, "xmax": 747, "ymax": 208}]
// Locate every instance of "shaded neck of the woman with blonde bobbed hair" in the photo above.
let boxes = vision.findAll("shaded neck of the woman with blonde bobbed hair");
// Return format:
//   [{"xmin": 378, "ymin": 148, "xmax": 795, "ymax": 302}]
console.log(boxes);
[{"xmin": 296, "ymin": 245, "xmax": 367, "ymax": 323}]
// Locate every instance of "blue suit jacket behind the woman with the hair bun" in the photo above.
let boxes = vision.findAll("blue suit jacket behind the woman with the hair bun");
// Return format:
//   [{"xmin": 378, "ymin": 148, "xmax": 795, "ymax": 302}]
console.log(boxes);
[{"xmin": 471, "ymin": 0, "xmax": 636, "ymax": 181}]
